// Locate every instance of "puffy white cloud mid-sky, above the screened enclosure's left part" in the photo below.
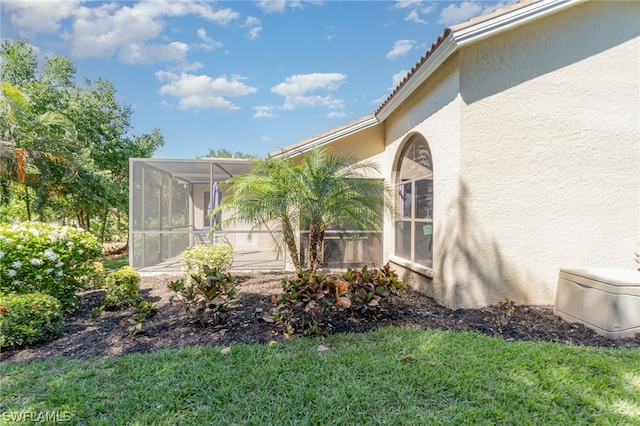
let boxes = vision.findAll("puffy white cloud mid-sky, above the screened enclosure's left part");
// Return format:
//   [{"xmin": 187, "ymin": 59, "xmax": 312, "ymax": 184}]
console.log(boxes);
[{"xmin": 156, "ymin": 71, "xmax": 257, "ymax": 112}]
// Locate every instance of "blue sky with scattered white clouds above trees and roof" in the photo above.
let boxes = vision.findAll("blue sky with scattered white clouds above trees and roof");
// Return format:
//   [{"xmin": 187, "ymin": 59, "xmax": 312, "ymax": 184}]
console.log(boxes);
[{"xmin": 0, "ymin": 0, "xmax": 513, "ymax": 158}]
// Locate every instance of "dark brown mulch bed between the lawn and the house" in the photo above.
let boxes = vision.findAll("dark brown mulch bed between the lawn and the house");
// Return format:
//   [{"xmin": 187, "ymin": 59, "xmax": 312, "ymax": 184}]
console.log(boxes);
[{"xmin": 1, "ymin": 273, "xmax": 640, "ymax": 363}]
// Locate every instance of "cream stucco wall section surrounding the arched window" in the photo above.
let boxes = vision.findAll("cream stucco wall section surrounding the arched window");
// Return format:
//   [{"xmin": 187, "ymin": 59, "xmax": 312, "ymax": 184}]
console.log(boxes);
[{"xmin": 384, "ymin": 56, "xmax": 461, "ymax": 304}]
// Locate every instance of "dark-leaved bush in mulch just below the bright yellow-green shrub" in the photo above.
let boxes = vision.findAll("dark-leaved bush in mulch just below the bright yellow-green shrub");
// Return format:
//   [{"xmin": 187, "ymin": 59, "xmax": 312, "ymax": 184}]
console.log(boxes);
[{"xmin": 169, "ymin": 266, "xmax": 236, "ymax": 327}]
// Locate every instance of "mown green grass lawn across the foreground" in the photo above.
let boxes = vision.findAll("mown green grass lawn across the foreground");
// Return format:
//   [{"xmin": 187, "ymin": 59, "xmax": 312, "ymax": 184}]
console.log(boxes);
[{"xmin": 0, "ymin": 328, "xmax": 640, "ymax": 425}]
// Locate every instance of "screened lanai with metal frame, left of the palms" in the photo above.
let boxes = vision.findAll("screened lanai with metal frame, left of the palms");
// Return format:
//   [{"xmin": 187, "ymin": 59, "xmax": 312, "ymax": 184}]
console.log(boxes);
[{"xmin": 129, "ymin": 158, "xmax": 285, "ymax": 273}]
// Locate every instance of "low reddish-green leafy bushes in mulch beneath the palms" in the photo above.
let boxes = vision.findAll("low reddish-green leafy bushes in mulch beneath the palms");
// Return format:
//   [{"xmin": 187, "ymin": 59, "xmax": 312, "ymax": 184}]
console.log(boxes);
[{"xmin": 272, "ymin": 263, "xmax": 405, "ymax": 334}]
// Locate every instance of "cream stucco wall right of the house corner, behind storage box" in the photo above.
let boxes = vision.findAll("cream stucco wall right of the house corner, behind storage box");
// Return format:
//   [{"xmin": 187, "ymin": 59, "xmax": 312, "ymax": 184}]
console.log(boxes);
[{"xmin": 452, "ymin": 2, "xmax": 640, "ymax": 306}]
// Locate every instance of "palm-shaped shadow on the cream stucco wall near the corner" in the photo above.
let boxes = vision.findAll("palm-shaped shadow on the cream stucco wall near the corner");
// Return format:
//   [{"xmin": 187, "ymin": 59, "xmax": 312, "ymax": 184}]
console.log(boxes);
[{"xmin": 433, "ymin": 183, "xmax": 539, "ymax": 308}]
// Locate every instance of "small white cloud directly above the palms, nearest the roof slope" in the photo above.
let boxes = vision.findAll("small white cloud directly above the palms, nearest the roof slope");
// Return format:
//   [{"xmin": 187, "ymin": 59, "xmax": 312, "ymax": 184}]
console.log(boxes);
[{"xmin": 271, "ymin": 73, "xmax": 347, "ymax": 109}]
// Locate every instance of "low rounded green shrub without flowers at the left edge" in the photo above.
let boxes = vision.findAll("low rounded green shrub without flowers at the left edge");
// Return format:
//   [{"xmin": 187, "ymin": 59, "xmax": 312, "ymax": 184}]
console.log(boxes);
[{"xmin": 0, "ymin": 293, "xmax": 64, "ymax": 347}]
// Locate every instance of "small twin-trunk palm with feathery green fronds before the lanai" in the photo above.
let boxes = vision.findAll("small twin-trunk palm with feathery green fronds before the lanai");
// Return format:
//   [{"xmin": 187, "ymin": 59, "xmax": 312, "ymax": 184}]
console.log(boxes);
[{"xmin": 221, "ymin": 148, "xmax": 393, "ymax": 272}]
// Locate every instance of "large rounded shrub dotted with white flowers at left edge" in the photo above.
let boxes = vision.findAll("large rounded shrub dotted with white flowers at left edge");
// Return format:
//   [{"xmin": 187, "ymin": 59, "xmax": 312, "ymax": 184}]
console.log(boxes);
[{"xmin": 0, "ymin": 222, "xmax": 102, "ymax": 311}]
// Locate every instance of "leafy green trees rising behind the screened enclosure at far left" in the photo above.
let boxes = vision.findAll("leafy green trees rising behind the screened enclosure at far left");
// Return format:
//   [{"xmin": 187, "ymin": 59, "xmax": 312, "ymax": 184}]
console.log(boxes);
[{"xmin": 0, "ymin": 38, "xmax": 164, "ymax": 240}]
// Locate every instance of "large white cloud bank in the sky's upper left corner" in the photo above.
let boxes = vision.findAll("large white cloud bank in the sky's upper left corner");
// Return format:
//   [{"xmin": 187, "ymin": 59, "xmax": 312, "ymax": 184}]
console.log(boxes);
[{"xmin": 2, "ymin": 0, "xmax": 240, "ymax": 63}]
